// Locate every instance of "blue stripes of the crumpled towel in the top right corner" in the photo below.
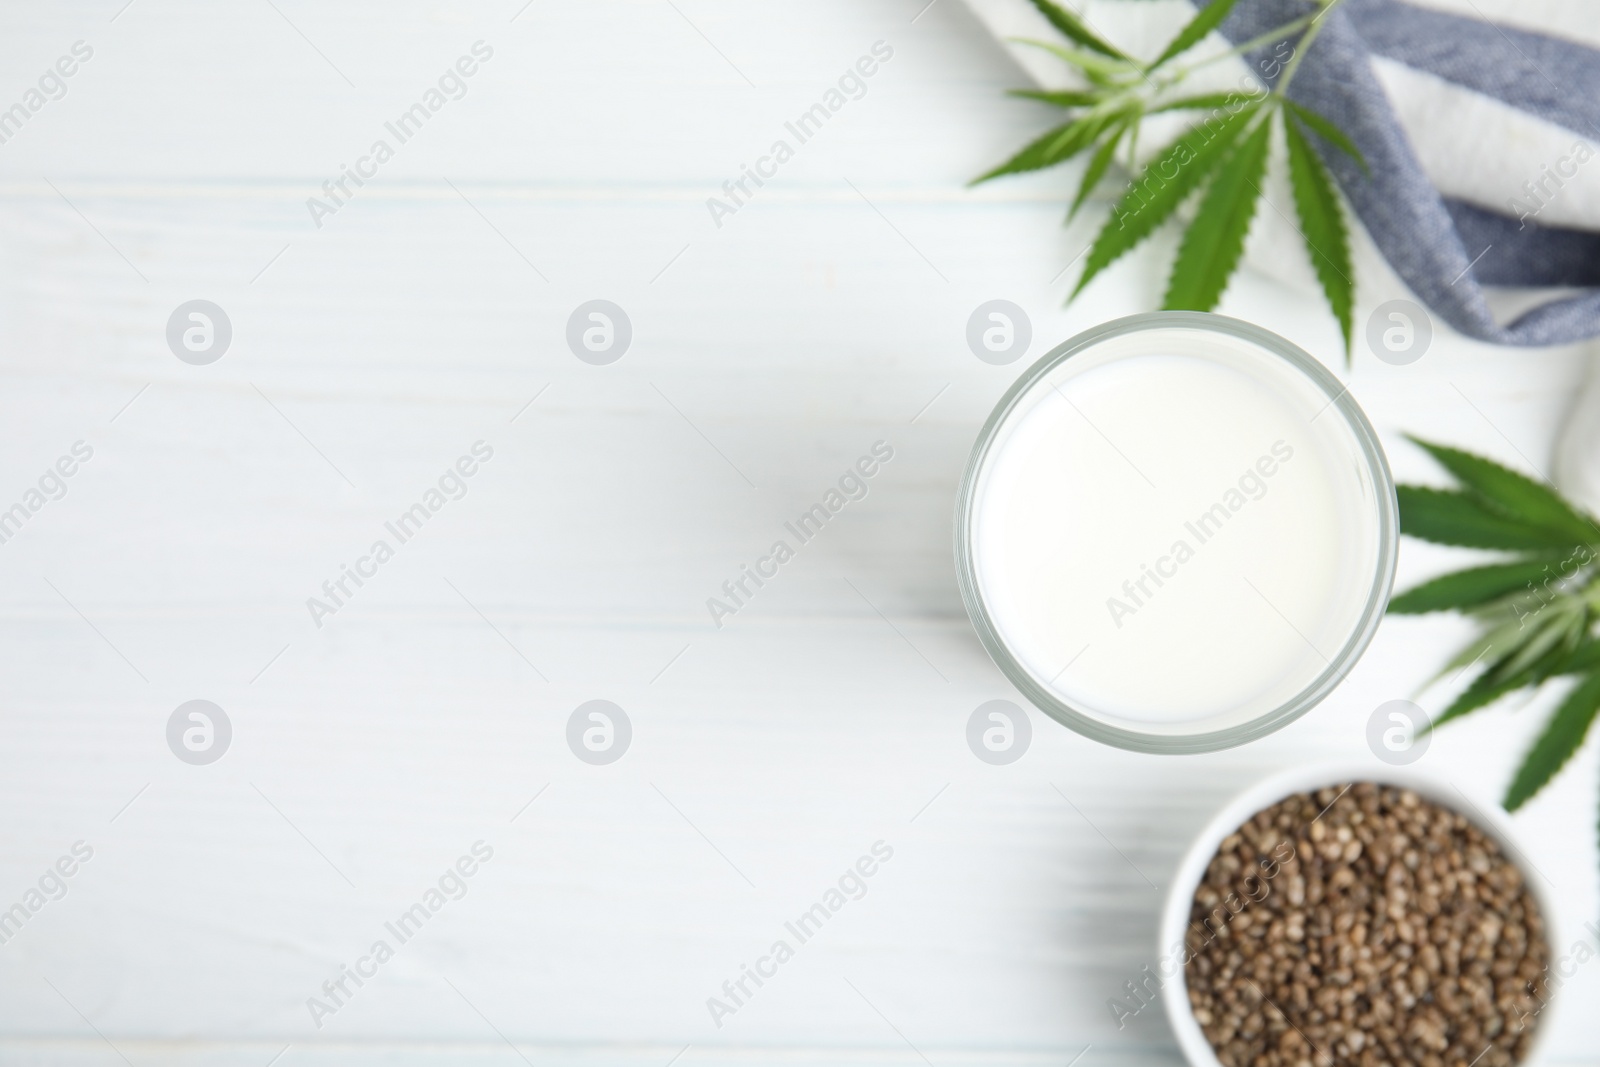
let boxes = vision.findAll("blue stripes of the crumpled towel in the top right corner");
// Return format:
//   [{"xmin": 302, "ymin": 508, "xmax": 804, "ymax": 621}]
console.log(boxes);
[{"xmin": 1222, "ymin": 0, "xmax": 1600, "ymax": 346}]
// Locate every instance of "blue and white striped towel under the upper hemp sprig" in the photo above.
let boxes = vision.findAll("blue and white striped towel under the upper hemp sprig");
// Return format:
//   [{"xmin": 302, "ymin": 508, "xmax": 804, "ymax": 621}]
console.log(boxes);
[{"xmin": 968, "ymin": 0, "xmax": 1600, "ymax": 346}]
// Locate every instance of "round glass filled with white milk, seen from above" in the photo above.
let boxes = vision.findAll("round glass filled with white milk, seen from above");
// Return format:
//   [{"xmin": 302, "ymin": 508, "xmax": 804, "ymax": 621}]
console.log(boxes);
[{"xmin": 955, "ymin": 312, "xmax": 1398, "ymax": 752}]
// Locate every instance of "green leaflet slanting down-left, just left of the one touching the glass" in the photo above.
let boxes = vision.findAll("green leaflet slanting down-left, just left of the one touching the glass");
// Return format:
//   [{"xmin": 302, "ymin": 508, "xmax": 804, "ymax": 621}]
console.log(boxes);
[{"xmin": 1069, "ymin": 107, "xmax": 1258, "ymax": 299}]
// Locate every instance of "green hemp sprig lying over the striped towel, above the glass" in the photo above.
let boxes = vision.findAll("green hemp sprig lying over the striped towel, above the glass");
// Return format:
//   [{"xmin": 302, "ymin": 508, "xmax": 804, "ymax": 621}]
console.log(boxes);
[{"xmin": 973, "ymin": 0, "xmax": 1366, "ymax": 360}]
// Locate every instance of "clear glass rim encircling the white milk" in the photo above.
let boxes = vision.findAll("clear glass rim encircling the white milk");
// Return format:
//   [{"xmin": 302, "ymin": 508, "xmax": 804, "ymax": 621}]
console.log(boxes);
[{"xmin": 955, "ymin": 312, "xmax": 1400, "ymax": 755}]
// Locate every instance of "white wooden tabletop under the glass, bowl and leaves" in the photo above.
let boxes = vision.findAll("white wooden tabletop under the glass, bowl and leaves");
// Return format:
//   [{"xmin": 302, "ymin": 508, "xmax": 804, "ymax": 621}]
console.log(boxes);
[{"xmin": 0, "ymin": 0, "xmax": 1600, "ymax": 1067}]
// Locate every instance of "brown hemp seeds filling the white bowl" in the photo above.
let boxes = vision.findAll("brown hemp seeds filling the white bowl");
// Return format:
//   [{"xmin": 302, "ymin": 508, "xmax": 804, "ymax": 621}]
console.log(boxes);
[{"xmin": 1184, "ymin": 782, "xmax": 1549, "ymax": 1067}]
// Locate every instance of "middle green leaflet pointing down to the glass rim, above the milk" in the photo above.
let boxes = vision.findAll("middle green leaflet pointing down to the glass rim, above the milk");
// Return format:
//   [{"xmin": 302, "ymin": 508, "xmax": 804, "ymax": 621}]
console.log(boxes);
[{"xmin": 1162, "ymin": 115, "xmax": 1272, "ymax": 312}]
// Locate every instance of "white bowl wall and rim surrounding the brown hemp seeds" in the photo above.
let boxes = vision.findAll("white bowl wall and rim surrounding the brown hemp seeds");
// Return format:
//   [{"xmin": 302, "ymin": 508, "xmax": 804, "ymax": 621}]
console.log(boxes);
[{"xmin": 1157, "ymin": 763, "xmax": 1565, "ymax": 1067}]
